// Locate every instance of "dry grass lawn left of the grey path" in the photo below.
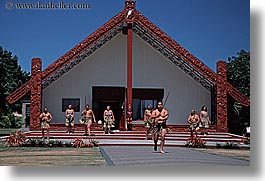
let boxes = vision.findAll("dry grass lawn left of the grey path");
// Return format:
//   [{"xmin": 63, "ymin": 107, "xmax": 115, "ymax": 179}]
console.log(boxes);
[{"xmin": 0, "ymin": 142, "xmax": 106, "ymax": 166}]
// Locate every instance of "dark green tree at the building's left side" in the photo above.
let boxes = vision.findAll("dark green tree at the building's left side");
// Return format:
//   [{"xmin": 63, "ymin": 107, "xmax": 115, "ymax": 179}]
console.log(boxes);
[{"xmin": 0, "ymin": 46, "xmax": 30, "ymax": 116}]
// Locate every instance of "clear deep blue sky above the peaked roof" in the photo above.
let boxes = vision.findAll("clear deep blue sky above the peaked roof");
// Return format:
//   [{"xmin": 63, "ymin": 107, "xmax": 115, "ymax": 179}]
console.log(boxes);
[{"xmin": 0, "ymin": 0, "xmax": 250, "ymax": 72}]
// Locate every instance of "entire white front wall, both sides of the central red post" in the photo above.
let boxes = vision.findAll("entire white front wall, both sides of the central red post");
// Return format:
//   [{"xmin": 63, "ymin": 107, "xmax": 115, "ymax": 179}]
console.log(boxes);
[{"xmin": 42, "ymin": 33, "xmax": 211, "ymax": 124}]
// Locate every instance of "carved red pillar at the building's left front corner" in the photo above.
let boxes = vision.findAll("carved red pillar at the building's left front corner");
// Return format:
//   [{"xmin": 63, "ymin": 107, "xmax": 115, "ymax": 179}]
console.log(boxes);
[{"xmin": 30, "ymin": 58, "xmax": 42, "ymax": 130}]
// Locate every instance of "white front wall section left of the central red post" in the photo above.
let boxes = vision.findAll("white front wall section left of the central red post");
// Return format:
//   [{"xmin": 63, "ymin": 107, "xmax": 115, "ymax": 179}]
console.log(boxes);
[{"xmin": 42, "ymin": 35, "xmax": 127, "ymax": 123}]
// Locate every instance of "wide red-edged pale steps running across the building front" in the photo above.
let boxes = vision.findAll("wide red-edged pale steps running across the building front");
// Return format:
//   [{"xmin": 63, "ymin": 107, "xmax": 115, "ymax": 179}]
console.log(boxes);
[{"xmin": 0, "ymin": 131, "xmax": 249, "ymax": 147}]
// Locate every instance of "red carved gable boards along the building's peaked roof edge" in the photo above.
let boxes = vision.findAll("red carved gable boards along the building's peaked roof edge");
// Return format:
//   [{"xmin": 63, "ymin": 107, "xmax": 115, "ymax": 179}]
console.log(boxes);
[{"xmin": 6, "ymin": 1, "xmax": 250, "ymax": 106}]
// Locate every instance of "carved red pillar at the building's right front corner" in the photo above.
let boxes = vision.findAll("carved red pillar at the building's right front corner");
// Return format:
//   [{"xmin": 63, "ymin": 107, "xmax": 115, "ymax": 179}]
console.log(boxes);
[{"xmin": 216, "ymin": 61, "xmax": 227, "ymax": 132}]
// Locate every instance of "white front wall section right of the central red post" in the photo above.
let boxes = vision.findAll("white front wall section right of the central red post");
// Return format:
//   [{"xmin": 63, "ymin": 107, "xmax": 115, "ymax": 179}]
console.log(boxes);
[{"xmin": 133, "ymin": 35, "xmax": 211, "ymax": 124}]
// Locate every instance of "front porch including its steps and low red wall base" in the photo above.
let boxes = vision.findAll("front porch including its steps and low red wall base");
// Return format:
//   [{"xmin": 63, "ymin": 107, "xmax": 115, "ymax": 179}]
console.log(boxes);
[{"xmin": 0, "ymin": 124, "xmax": 250, "ymax": 149}]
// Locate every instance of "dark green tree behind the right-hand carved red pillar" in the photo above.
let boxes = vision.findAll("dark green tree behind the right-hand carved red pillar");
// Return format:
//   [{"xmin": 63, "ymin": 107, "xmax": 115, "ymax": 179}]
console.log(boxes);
[{"xmin": 227, "ymin": 50, "xmax": 250, "ymax": 134}]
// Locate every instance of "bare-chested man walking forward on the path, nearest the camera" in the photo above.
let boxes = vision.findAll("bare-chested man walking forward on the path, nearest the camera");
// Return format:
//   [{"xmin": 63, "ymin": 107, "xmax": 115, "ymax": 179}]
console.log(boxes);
[{"xmin": 151, "ymin": 102, "xmax": 168, "ymax": 154}]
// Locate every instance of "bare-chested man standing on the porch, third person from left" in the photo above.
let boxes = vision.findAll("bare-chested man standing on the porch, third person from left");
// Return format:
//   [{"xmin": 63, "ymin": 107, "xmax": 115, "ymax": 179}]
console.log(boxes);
[{"xmin": 80, "ymin": 104, "xmax": 96, "ymax": 136}]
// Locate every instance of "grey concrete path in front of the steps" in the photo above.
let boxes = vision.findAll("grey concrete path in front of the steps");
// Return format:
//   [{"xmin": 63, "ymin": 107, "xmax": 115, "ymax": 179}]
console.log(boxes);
[{"xmin": 100, "ymin": 146, "xmax": 250, "ymax": 166}]
